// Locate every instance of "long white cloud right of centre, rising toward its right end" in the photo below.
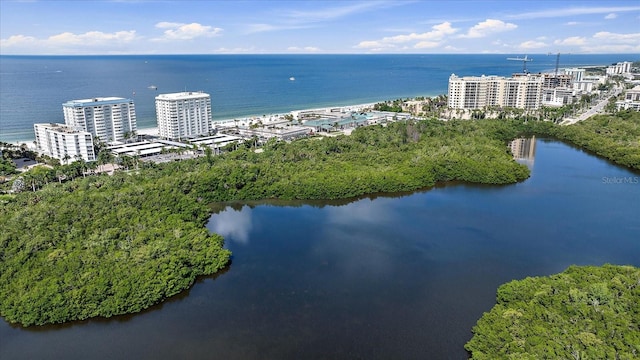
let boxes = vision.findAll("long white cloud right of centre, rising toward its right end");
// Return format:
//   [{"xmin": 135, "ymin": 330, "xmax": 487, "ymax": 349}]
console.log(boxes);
[{"xmin": 356, "ymin": 22, "xmax": 458, "ymax": 49}]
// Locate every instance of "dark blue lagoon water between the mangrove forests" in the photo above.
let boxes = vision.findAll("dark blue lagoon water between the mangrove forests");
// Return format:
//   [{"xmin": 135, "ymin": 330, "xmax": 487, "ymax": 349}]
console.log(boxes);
[{"xmin": 0, "ymin": 140, "xmax": 640, "ymax": 359}]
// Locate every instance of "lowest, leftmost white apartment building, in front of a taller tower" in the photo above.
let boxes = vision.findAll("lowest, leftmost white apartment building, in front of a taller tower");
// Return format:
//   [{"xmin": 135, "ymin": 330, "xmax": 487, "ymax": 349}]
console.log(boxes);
[{"xmin": 33, "ymin": 123, "xmax": 96, "ymax": 163}]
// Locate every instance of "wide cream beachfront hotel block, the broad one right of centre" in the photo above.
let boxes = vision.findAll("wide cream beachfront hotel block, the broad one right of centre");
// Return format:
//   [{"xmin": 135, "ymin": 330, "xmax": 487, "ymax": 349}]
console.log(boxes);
[{"xmin": 448, "ymin": 74, "xmax": 544, "ymax": 109}]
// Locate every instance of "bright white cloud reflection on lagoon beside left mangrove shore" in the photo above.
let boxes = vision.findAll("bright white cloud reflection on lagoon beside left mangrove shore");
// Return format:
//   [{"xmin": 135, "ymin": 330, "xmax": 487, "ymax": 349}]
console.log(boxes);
[{"xmin": 207, "ymin": 206, "xmax": 252, "ymax": 245}]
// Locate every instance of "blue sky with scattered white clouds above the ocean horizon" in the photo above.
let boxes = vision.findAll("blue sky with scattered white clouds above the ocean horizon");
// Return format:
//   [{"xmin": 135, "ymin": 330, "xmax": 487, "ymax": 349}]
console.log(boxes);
[{"xmin": 0, "ymin": 0, "xmax": 640, "ymax": 55}]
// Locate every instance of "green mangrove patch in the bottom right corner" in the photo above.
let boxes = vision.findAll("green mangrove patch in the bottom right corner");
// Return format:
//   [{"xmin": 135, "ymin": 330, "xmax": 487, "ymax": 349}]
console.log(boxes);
[{"xmin": 465, "ymin": 265, "xmax": 640, "ymax": 360}]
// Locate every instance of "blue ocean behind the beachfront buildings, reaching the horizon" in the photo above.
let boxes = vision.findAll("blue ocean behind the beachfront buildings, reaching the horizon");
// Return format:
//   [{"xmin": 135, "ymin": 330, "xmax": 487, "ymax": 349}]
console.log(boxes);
[{"xmin": 0, "ymin": 54, "xmax": 640, "ymax": 142}]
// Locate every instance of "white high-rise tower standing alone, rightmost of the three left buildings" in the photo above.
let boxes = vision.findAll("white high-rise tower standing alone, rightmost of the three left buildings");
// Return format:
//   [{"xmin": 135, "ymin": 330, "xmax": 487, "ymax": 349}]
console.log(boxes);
[{"xmin": 156, "ymin": 91, "xmax": 212, "ymax": 140}]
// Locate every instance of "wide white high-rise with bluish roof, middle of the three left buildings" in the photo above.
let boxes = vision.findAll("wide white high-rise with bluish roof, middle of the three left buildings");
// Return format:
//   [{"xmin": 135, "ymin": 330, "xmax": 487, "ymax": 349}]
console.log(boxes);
[{"xmin": 62, "ymin": 97, "xmax": 137, "ymax": 143}]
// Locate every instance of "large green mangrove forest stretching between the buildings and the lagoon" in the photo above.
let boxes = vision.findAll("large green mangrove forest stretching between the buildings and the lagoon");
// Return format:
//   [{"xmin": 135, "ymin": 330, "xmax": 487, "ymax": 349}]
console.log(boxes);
[{"xmin": 0, "ymin": 113, "xmax": 640, "ymax": 326}]
